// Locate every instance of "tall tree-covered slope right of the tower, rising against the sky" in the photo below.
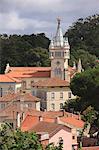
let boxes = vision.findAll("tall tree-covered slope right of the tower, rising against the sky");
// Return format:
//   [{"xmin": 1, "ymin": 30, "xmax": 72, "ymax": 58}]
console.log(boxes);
[{"xmin": 65, "ymin": 15, "xmax": 99, "ymax": 69}]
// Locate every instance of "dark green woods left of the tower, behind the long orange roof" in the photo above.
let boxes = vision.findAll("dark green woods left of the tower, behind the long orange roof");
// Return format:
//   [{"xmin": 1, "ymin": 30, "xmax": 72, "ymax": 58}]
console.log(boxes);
[{"xmin": 0, "ymin": 33, "xmax": 50, "ymax": 72}]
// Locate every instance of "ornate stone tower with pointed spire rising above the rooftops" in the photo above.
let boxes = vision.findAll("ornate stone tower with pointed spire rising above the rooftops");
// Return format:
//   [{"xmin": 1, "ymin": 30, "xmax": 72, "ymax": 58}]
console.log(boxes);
[{"xmin": 49, "ymin": 18, "xmax": 70, "ymax": 81}]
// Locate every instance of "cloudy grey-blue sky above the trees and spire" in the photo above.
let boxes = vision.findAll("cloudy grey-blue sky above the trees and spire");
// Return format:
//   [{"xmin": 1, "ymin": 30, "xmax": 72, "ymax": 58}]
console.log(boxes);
[{"xmin": 0, "ymin": 0, "xmax": 99, "ymax": 37}]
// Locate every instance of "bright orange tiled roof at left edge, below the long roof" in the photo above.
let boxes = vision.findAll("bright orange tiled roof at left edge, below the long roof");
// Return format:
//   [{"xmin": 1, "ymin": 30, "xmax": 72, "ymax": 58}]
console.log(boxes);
[{"xmin": 0, "ymin": 74, "xmax": 21, "ymax": 83}]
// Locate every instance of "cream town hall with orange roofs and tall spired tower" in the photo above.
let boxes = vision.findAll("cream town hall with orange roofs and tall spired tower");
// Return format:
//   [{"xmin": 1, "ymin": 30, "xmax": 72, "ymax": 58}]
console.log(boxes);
[{"xmin": 0, "ymin": 19, "xmax": 82, "ymax": 111}]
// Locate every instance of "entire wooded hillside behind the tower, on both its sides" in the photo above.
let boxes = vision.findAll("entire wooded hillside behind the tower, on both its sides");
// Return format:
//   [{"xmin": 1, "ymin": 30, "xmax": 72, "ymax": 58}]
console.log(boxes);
[{"xmin": 0, "ymin": 15, "xmax": 99, "ymax": 73}]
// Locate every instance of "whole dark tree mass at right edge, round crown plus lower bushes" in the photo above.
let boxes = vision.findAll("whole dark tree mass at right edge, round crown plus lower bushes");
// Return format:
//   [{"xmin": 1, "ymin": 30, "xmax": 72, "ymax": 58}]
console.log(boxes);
[{"xmin": 69, "ymin": 67, "xmax": 99, "ymax": 127}]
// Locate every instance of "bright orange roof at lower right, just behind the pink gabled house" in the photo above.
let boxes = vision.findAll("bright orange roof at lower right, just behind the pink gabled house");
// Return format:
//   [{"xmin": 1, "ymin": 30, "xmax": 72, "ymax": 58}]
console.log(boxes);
[{"xmin": 60, "ymin": 117, "xmax": 84, "ymax": 128}]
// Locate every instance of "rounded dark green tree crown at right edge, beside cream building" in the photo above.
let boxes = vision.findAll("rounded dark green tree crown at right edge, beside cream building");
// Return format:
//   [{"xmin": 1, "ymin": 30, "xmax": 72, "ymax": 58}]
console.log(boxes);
[{"xmin": 70, "ymin": 67, "xmax": 99, "ymax": 110}]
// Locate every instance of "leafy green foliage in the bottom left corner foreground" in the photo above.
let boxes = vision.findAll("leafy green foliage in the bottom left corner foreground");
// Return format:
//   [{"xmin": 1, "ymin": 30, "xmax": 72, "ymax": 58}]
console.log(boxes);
[{"xmin": 0, "ymin": 125, "xmax": 42, "ymax": 150}]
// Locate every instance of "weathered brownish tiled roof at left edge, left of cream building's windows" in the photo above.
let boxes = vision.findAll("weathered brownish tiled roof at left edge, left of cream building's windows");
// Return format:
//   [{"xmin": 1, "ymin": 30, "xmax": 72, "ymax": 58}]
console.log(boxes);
[{"xmin": 0, "ymin": 93, "xmax": 40, "ymax": 102}]
